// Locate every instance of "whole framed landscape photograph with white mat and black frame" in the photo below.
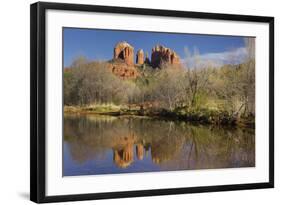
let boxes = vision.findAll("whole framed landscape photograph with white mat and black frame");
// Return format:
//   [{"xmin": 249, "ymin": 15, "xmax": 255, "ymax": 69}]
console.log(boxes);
[{"xmin": 30, "ymin": 2, "xmax": 274, "ymax": 203}]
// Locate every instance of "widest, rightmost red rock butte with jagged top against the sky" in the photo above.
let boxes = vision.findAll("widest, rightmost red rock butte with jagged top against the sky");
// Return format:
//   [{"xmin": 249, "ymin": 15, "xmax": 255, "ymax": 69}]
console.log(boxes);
[{"xmin": 151, "ymin": 45, "xmax": 180, "ymax": 68}]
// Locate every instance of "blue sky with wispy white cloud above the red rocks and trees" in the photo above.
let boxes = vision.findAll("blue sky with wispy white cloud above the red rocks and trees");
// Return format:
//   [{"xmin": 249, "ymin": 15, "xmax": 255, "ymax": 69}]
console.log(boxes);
[{"xmin": 63, "ymin": 28, "xmax": 246, "ymax": 67}]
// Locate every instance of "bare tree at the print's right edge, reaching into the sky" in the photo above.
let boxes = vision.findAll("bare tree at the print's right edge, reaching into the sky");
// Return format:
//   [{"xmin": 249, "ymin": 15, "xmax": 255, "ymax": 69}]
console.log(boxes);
[{"xmin": 209, "ymin": 38, "xmax": 255, "ymax": 118}]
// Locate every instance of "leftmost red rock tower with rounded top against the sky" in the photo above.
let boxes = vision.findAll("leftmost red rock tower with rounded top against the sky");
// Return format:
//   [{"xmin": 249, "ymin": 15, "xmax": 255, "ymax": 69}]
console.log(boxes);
[{"xmin": 114, "ymin": 41, "xmax": 134, "ymax": 65}]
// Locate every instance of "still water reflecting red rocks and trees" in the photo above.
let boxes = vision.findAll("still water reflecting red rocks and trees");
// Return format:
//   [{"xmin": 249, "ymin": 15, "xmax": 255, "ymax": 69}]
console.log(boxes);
[{"xmin": 63, "ymin": 115, "xmax": 255, "ymax": 176}]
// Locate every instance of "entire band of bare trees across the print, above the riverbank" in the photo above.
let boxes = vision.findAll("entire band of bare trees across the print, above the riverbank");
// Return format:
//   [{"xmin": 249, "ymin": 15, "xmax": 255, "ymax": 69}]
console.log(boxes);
[{"xmin": 64, "ymin": 39, "xmax": 255, "ymax": 121}]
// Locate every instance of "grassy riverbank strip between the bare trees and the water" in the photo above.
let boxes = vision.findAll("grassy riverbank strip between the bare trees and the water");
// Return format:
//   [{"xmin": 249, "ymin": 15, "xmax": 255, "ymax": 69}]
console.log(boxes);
[{"xmin": 64, "ymin": 104, "xmax": 255, "ymax": 128}]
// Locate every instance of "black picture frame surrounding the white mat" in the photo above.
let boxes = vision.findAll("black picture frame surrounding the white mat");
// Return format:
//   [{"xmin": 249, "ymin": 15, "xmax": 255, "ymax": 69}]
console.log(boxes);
[{"xmin": 30, "ymin": 2, "xmax": 274, "ymax": 203}]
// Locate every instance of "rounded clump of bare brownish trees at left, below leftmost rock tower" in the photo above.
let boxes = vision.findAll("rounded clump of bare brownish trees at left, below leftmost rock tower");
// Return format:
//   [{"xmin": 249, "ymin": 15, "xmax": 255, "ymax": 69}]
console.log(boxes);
[{"xmin": 64, "ymin": 60, "xmax": 136, "ymax": 105}]
